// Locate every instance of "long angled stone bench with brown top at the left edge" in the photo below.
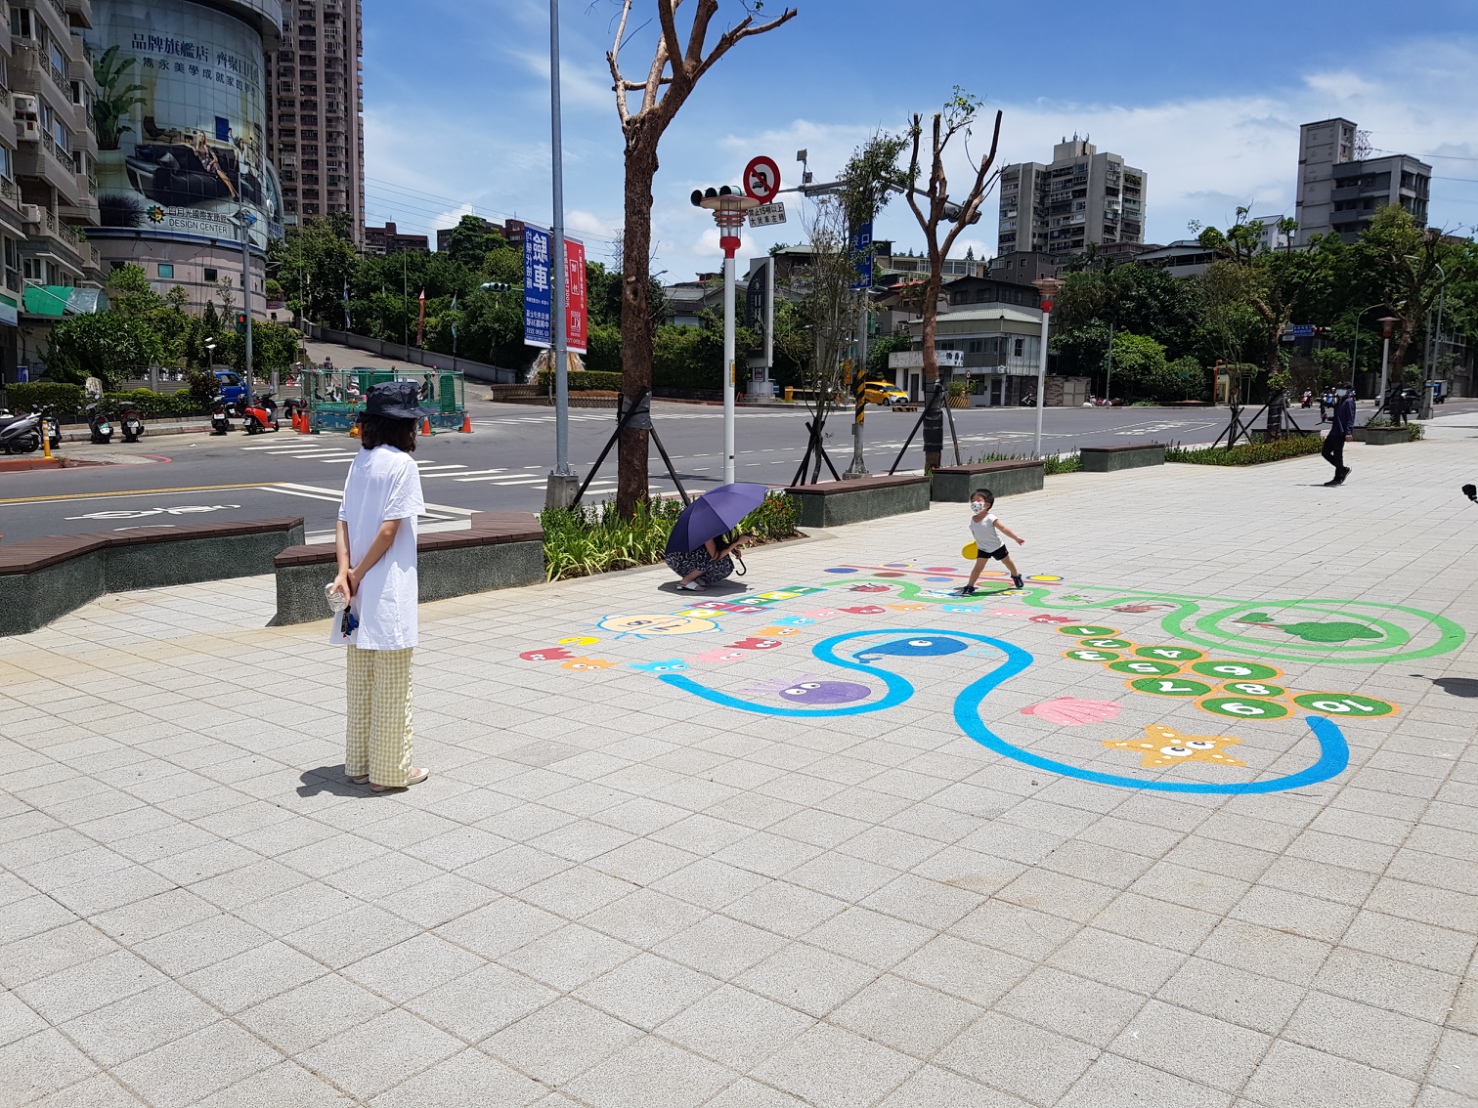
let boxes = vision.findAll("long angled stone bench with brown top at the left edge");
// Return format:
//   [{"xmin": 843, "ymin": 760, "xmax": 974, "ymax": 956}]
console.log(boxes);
[{"xmin": 0, "ymin": 516, "xmax": 303, "ymax": 635}]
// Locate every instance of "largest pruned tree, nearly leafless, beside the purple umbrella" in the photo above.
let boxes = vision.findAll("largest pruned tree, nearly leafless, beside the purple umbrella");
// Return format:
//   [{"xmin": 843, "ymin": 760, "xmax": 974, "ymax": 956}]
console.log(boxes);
[{"xmin": 606, "ymin": 0, "xmax": 795, "ymax": 516}]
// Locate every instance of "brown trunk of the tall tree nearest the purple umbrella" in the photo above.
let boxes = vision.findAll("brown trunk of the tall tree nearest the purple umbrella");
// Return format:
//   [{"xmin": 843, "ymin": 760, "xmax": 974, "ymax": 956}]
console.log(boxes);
[{"xmin": 616, "ymin": 127, "xmax": 662, "ymax": 519}]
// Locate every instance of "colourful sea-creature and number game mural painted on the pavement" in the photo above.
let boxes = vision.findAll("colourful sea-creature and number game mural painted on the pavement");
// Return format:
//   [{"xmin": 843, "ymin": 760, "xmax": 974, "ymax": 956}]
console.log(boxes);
[{"xmin": 519, "ymin": 563, "xmax": 1465, "ymax": 793}]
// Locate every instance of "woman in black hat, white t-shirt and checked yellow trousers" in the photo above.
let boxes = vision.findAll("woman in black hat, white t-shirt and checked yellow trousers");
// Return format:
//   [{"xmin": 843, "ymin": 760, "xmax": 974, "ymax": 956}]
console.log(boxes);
[{"xmin": 330, "ymin": 381, "xmax": 429, "ymax": 792}]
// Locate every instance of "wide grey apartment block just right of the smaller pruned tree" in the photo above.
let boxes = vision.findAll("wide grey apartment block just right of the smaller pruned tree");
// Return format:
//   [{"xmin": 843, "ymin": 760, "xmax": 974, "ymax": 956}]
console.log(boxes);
[{"xmin": 996, "ymin": 134, "xmax": 1147, "ymax": 254}]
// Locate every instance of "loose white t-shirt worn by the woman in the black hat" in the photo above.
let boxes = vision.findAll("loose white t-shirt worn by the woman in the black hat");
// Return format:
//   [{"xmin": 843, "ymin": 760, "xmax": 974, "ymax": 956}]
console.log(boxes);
[{"xmin": 333, "ymin": 446, "xmax": 426, "ymax": 650}]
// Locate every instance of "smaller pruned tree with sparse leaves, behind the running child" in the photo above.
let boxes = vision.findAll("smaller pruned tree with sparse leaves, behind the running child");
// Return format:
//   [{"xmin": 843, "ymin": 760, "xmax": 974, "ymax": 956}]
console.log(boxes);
[{"xmin": 905, "ymin": 84, "xmax": 1005, "ymax": 470}]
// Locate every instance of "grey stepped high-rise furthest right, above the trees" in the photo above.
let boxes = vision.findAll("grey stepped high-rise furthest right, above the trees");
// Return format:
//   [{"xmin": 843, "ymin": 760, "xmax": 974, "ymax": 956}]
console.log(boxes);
[{"xmin": 1293, "ymin": 118, "xmax": 1432, "ymax": 242}]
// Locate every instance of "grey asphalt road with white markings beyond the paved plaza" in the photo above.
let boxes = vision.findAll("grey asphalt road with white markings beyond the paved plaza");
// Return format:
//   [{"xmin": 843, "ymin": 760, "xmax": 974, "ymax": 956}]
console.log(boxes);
[{"xmin": 0, "ymin": 400, "xmax": 1436, "ymax": 542}]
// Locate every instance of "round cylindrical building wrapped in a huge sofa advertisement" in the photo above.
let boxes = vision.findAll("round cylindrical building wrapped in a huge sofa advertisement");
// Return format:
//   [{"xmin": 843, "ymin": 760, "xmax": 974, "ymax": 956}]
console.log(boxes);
[{"xmin": 81, "ymin": 0, "xmax": 282, "ymax": 320}]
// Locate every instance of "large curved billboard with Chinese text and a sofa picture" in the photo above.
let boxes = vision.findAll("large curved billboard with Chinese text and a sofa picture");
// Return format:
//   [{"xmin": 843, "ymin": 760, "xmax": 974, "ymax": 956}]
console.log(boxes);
[{"xmin": 87, "ymin": 0, "xmax": 282, "ymax": 248}]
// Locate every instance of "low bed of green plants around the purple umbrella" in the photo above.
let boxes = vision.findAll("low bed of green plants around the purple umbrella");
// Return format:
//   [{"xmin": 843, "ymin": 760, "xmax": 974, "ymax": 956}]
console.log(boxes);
[{"xmin": 539, "ymin": 492, "xmax": 800, "ymax": 581}]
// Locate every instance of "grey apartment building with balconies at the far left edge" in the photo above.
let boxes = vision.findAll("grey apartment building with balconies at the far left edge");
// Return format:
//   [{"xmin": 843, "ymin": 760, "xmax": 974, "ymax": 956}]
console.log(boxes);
[{"xmin": 0, "ymin": 0, "xmax": 101, "ymax": 377}]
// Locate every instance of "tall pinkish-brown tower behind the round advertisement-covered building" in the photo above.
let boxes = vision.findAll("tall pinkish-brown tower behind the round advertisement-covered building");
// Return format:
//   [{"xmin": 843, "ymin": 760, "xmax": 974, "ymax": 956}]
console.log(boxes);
[{"xmin": 268, "ymin": 0, "xmax": 365, "ymax": 244}]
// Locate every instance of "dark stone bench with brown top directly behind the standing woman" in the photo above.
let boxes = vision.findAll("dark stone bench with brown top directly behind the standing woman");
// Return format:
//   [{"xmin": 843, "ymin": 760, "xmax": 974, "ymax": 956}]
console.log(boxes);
[{"xmin": 272, "ymin": 511, "xmax": 544, "ymax": 626}]
